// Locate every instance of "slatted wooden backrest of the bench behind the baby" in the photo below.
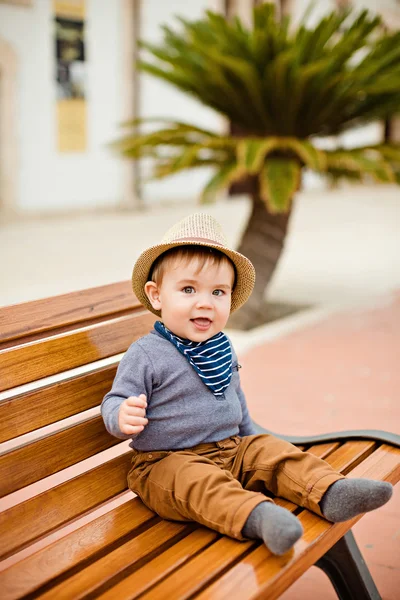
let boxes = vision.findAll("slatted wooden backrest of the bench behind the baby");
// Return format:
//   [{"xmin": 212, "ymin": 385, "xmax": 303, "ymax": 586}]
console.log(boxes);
[{"xmin": 0, "ymin": 282, "xmax": 155, "ymax": 558}]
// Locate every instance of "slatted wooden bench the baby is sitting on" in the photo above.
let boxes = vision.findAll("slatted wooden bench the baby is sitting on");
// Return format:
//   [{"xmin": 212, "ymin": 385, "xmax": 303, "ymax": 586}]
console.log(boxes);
[{"xmin": 0, "ymin": 282, "xmax": 400, "ymax": 600}]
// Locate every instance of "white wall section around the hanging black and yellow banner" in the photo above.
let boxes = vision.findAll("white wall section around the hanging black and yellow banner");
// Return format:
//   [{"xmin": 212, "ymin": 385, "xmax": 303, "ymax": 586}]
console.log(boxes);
[{"xmin": 0, "ymin": 0, "xmax": 126, "ymax": 212}]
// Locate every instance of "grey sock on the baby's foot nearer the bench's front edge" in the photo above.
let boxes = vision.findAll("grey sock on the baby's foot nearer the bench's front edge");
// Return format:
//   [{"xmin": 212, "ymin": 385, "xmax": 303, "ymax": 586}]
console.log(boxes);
[{"xmin": 242, "ymin": 502, "xmax": 303, "ymax": 555}]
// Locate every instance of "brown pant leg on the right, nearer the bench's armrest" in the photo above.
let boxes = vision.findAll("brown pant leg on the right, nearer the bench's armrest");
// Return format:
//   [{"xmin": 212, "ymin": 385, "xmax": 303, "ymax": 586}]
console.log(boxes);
[{"xmin": 232, "ymin": 434, "xmax": 344, "ymax": 516}]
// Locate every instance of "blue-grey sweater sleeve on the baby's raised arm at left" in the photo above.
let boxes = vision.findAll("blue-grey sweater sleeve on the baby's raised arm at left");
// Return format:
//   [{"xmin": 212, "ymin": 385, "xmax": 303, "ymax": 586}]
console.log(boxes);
[{"xmin": 101, "ymin": 342, "xmax": 153, "ymax": 440}]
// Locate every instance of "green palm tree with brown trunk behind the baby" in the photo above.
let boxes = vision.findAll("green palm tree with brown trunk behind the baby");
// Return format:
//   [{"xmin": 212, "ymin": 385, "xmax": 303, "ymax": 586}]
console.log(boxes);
[{"xmin": 115, "ymin": 4, "xmax": 400, "ymax": 328}]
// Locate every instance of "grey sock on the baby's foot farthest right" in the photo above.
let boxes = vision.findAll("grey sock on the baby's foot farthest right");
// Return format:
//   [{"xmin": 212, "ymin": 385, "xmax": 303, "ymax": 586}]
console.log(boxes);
[{"xmin": 320, "ymin": 479, "xmax": 393, "ymax": 523}]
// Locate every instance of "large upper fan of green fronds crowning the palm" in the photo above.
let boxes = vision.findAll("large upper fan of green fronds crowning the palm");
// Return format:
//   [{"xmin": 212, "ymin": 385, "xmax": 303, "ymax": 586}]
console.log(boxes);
[{"xmin": 134, "ymin": 3, "xmax": 400, "ymax": 138}]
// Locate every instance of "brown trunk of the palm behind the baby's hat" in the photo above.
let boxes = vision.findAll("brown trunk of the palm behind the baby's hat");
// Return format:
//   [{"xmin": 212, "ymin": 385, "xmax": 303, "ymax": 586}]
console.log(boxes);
[{"xmin": 229, "ymin": 192, "xmax": 291, "ymax": 329}]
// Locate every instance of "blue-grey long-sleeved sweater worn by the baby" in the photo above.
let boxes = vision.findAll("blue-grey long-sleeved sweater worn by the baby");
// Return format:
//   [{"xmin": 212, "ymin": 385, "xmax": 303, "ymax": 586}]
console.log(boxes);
[{"xmin": 101, "ymin": 330, "xmax": 256, "ymax": 452}]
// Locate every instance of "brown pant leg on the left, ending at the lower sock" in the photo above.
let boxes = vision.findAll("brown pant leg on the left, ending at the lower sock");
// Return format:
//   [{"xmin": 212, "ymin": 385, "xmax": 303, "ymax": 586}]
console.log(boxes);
[{"xmin": 128, "ymin": 451, "xmax": 266, "ymax": 540}]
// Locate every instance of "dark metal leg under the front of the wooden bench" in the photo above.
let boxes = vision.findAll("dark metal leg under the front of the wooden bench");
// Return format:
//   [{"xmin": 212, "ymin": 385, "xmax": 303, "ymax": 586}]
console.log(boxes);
[{"xmin": 315, "ymin": 531, "xmax": 381, "ymax": 600}]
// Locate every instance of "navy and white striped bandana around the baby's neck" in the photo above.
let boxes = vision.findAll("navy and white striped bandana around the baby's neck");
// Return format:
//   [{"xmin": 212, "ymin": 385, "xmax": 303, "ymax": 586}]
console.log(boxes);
[{"xmin": 154, "ymin": 321, "xmax": 232, "ymax": 396}]
